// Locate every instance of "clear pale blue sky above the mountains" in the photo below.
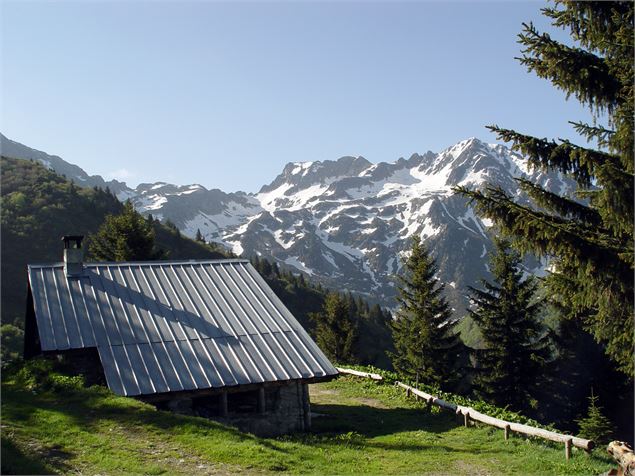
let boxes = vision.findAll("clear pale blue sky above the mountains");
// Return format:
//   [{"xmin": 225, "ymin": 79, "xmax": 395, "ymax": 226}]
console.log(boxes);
[{"xmin": 1, "ymin": 1, "xmax": 588, "ymax": 191}]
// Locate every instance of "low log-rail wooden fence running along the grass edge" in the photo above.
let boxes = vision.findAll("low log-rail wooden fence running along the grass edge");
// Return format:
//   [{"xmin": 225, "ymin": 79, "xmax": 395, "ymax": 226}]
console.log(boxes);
[{"xmin": 337, "ymin": 368, "xmax": 595, "ymax": 460}]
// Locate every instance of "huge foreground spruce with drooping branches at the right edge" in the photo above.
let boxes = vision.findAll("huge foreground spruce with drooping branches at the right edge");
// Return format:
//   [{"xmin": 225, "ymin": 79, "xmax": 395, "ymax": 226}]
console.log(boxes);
[{"xmin": 457, "ymin": 1, "xmax": 635, "ymax": 377}]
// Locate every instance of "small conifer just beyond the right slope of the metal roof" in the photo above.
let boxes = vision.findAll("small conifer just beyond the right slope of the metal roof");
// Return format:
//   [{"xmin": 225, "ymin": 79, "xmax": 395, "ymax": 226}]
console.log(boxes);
[{"xmin": 312, "ymin": 292, "xmax": 358, "ymax": 363}]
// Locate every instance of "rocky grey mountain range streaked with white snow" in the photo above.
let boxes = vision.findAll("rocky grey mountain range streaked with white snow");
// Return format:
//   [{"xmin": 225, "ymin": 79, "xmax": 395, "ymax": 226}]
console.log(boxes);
[{"xmin": 3, "ymin": 133, "xmax": 575, "ymax": 307}]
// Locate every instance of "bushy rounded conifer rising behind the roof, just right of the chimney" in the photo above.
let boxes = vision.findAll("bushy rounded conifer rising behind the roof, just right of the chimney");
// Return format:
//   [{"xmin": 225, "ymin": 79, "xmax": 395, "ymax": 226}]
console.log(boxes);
[{"xmin": 88, "ymin": 200, "xmax": 161, "ymax": 261}]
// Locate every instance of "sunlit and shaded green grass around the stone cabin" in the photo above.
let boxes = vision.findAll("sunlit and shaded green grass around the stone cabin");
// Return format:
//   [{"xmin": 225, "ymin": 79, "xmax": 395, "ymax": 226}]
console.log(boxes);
[{"xmin": 2, "ymin": 366, "xmax": 611, "ymax": 475}]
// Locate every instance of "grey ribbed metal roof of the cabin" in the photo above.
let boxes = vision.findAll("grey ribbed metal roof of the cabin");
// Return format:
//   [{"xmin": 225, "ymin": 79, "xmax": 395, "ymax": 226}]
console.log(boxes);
[{"xmin": 28, "ymin": 260, "xmax": 337, "ymax": 396}]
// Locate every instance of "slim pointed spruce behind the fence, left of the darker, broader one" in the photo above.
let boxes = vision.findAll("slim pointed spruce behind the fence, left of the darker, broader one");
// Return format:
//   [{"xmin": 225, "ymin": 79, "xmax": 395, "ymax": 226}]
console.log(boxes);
[{"xmin": 390, "ymin": 236, "xmax": 462, "ymax": 389}]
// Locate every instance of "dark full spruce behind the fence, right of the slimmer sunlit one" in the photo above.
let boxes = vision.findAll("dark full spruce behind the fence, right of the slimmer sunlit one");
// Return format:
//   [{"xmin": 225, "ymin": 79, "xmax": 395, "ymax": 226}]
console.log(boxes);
[{"xmin": 468, "ymin": 238, "xmax": 550, "ymax": 411}]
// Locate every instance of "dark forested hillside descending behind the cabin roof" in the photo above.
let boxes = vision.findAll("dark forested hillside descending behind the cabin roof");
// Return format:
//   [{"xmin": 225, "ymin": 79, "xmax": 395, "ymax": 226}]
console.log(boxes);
[{"xmin": 1, "ymin": 157, "xmax": 391, "ymax": 366}]
